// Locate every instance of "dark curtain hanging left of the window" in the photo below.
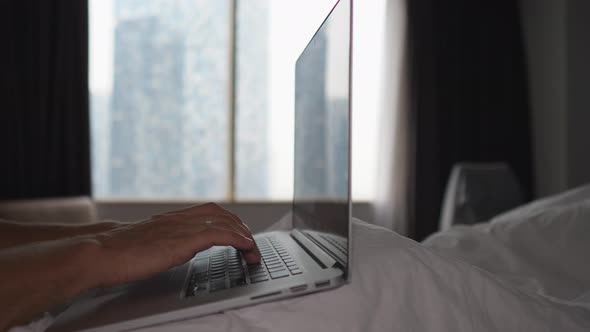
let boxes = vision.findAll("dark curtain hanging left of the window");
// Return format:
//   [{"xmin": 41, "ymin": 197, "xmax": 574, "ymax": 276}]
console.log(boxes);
[{"xmin": 0, "ymin": 0, "xmax": 90, "ymax": 199}]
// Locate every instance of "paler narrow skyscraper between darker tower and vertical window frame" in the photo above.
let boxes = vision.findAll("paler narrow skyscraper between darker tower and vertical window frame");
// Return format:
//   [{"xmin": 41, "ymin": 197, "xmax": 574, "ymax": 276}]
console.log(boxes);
[{"xmin": 183, "ymin": 0, "xmax": 231, "ymax": 199}]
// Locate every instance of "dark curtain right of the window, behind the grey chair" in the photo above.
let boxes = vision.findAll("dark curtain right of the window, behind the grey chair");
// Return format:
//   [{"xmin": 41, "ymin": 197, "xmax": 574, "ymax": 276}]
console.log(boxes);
[{"xmin": 408, "ymin": 0, "xmax": 532, "ymax": 240}]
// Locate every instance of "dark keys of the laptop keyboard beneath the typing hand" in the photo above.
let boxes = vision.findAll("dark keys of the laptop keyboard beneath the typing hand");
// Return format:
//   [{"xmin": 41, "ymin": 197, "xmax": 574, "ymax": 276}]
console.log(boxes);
[{"xmin": 186, "ymin": 237, "xmax": 302, "ymax": 296}]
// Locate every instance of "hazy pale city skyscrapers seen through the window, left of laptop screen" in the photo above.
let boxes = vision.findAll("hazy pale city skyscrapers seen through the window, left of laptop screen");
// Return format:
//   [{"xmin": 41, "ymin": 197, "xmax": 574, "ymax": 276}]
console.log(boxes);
[{"xmin": 92, "ymin": 0, "xmax": 268, "ymax": 199}]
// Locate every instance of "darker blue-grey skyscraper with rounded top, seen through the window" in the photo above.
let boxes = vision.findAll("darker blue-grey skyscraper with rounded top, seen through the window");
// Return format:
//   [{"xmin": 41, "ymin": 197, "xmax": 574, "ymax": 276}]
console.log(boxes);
[{"xmin": 110, "ymin": 17, "xmax": 184, "ymax": 197}]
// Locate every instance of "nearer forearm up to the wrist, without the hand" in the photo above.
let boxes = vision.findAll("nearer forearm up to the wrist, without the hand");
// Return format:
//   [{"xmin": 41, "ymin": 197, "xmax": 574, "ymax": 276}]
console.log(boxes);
[{"xmin": 0, "ymin": 237, "xmax": 100, "ymax": 331}]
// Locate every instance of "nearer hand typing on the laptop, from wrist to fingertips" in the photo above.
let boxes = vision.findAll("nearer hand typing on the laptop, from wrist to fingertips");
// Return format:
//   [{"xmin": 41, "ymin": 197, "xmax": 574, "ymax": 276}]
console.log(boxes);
[{"xmin": 94, "ymin": 203, "xmax": 260, "ymax": 286}]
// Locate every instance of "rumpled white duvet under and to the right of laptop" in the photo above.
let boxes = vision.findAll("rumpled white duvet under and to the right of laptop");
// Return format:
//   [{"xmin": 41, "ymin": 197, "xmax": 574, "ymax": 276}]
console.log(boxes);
[{"xmin": 13, "ymin": 187, "xmax": 590, "ymax": 332}]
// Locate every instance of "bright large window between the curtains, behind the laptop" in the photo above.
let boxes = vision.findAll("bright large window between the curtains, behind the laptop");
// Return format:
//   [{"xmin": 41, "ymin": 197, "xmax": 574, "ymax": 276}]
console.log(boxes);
[{"xmin": 89, "ymin": 0, "xmax": 383, "ymax": 201}]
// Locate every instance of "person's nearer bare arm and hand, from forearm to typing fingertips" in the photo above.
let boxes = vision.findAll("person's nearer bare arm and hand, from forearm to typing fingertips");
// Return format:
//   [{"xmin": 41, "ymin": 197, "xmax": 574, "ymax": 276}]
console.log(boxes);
[{"xmin": 0, "ymin": 203, "xmax": 260, "ymax": 331}]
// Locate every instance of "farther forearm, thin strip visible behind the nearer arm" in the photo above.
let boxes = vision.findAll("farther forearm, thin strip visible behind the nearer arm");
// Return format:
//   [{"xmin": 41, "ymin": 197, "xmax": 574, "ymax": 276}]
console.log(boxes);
[{"xmin": 0, "ymin": 220, "xmax": 121, "ymax": 250}]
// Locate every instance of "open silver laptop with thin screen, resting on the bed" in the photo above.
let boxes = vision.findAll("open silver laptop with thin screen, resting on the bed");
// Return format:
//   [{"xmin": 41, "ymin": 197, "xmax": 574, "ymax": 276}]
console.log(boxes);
[{"xmin": 49, "ymin": 0, "xmax": 352, "ymax": 331}]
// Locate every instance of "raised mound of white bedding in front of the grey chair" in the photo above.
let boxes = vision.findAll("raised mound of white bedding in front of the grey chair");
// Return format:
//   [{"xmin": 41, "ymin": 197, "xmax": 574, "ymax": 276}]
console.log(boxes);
[{"xmin": 424, "ymin": 186, "xmax": 590, "ymax": 308}]
